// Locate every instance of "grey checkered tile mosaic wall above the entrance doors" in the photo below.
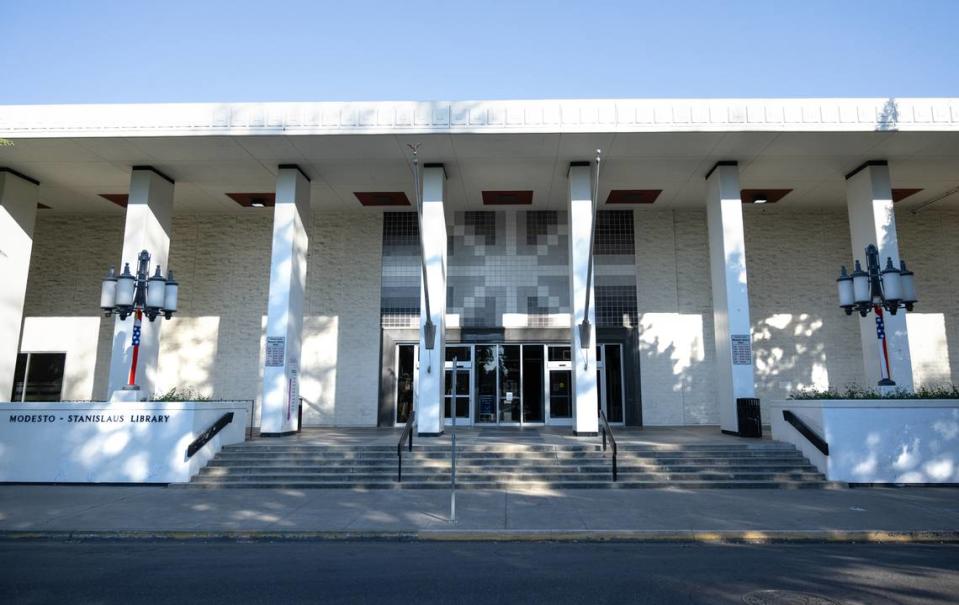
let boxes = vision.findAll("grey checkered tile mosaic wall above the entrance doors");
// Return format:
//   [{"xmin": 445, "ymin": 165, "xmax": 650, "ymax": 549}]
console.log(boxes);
[{"xmin": 381, "ymin": 210, "xmax": 636, "ymax": 328}]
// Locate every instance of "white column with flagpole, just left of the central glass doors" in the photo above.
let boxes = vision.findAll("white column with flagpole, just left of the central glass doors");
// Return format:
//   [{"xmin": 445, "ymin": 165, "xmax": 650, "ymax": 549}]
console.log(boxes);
[{"xmin": 416, "ymin": 164, "xmax": 446, "ymax": 435}]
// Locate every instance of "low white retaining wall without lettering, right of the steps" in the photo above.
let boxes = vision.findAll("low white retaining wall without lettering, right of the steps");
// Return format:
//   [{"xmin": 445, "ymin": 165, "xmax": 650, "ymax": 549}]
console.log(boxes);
[{"xmin": 769, "ymin": 399, "xmax": 959, "ymax": 484}]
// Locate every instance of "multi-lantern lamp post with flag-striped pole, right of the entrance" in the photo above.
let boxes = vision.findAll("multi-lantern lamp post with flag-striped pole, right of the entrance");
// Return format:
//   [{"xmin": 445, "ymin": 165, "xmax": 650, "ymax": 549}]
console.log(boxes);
[{"xmin": 836, "ymin": 244, "xmax": 917, "ymax": 387}]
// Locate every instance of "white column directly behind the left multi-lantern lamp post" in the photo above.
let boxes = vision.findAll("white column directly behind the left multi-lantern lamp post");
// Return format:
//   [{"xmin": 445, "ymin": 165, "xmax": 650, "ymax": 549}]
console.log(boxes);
[{"xmin": 108, "ymin": 166, "xmax": 173, "ymax": 399}]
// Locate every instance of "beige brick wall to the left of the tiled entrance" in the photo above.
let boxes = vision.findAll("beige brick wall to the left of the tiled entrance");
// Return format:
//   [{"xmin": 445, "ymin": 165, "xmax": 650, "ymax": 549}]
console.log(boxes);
[{"xmin": 27, "ymin": 211, "xmax": 382, "ymax": 426}]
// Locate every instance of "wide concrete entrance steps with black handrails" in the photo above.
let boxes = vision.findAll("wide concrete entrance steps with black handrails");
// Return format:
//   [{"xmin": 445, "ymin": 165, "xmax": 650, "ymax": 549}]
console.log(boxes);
[{"xmin": 188, "ymin": 440, "xmax": 828, "ymax": 489}]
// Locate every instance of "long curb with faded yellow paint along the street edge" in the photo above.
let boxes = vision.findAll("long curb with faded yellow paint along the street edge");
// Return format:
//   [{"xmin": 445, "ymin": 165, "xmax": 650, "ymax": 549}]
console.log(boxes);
[{"xmin": 0, "ymin": 530, "xmax": 959, "ymax": 544}]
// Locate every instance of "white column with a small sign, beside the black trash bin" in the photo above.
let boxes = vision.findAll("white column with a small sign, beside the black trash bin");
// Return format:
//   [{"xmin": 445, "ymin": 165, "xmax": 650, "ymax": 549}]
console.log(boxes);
[{"xmin": 706, "ymin": 162, "xmax": 756, "ymax": 433}]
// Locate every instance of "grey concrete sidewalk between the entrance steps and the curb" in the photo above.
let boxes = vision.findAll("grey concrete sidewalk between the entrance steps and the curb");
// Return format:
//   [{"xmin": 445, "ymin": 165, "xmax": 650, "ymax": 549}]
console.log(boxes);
[{"xmin": 0, "ymin": 485, "xmax": 959, "ymax": 542}]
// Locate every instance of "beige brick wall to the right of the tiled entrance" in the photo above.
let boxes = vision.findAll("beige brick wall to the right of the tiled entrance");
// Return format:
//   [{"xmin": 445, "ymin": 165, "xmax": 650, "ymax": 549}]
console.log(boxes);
[{"xmin": 634, "ymin": 206, "xmax": 959, "ymax": 425}]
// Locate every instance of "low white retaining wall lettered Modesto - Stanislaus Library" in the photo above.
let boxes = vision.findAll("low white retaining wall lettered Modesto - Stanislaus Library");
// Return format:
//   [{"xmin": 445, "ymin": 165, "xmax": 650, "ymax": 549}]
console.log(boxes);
[{"xmin": 0, "ymin": 401, "xmax": 250, "ymax": 483}]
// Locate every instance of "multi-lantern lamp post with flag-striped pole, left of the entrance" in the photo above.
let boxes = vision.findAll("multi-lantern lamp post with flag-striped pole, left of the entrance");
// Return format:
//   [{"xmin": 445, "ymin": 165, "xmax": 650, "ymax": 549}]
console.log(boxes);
[{"xmin": 100, "ymin": 250, "xmax": 179, "ymax": 390}]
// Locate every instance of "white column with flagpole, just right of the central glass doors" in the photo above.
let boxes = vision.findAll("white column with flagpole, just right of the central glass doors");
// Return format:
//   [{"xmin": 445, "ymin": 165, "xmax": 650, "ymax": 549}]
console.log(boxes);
[{"xmin": 568, "ymin": 162, "xmax": 599, "ymax": 435}]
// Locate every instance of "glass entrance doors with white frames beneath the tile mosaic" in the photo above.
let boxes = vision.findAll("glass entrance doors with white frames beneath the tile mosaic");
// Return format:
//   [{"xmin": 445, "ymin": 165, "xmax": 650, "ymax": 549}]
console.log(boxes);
[{"xmin": 395, "ymin": 343, "xmax": 625, "ymax": 426}]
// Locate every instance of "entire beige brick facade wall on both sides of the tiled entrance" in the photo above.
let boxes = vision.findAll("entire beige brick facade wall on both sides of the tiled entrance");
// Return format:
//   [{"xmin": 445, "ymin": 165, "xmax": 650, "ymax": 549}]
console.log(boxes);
[{"xmin": 18, "ymin": 210, "xmax": 959, "ymax": 426}]
